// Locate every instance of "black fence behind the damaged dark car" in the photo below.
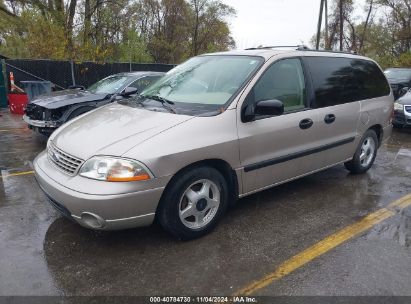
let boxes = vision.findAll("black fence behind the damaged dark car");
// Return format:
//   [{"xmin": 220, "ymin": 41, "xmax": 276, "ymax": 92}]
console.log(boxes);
[{"xmin": 6, "ymin": 59, "xmax": 174, "ymax": 90}]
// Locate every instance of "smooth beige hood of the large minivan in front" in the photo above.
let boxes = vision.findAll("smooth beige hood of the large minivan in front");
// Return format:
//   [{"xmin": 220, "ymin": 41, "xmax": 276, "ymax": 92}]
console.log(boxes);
[{"xmin": 50, "ymin": 103, "xmax": 193, "ymax": 160}]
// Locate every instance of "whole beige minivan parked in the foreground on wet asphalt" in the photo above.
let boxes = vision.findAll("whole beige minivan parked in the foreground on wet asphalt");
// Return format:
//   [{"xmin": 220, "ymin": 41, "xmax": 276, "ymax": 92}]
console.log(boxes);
[{"xmin": 34, "ymin": 48, "xmax": 394, "ymax": 239}]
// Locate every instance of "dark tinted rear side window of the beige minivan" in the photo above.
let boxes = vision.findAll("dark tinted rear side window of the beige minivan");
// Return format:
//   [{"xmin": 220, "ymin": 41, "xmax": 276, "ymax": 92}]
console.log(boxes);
[{"xmin": 306, "ymin": 57, "xmax": 390, "ymax": 108}]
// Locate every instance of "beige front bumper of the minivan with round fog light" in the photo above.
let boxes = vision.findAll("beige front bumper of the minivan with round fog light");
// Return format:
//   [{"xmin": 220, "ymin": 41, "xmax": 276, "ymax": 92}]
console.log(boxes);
[{"xmin": 34, "ymin": 152, "xmax": 166, "ymax": 230}]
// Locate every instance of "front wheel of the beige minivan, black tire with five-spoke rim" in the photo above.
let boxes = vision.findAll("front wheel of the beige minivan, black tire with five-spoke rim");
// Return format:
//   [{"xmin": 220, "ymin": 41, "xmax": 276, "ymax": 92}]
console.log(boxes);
[{"xmin": 157, "ymin": 167, "xmax": 228, "ymax": 240}]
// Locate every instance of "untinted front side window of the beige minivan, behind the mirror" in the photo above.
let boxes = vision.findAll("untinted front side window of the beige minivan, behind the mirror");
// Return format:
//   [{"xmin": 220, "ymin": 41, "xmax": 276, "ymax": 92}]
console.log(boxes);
[{"xmin": 247, "ymin": 58, "xmax": 306, "ymax": 112}]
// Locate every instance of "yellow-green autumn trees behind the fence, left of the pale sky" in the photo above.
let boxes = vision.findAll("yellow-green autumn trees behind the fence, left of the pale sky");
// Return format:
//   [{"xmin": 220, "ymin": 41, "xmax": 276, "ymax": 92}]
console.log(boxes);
[{"xmin": 0, "ymin": 0, "xmax": 235, "ymax": 63}]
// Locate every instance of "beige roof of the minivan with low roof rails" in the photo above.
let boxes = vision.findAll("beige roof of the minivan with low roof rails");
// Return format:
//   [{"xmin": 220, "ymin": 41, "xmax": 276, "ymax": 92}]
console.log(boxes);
[{"xmin": 208, "ymin": 48, "xmax": 370, "ymax": 60}]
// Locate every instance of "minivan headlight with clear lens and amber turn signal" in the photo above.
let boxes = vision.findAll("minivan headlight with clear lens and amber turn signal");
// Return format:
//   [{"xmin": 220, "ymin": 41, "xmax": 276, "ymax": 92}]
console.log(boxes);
[{"xmin": 79, "ymin": 156, "xmax": 153, "ymax": 182}]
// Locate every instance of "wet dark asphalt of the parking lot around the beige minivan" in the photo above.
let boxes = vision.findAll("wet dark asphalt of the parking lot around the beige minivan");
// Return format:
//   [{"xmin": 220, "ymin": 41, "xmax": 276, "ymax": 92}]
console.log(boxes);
[{"xmin": 0, "ymin": 111, "xmax": 411, "ymax": 296}]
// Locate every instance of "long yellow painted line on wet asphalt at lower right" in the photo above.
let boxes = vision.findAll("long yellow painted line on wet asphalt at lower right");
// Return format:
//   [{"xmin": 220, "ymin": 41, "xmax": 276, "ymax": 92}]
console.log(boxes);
[{"xmin": 234, "ymin": 194, "xmax": 411, "ymax": 296}]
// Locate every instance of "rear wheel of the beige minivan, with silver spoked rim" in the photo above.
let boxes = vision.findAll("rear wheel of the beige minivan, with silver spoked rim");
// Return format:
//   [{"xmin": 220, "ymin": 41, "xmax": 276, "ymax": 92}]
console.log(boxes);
[{"xmin": 344, "ymin": 130, "xmax": 378, "ymax": 174}]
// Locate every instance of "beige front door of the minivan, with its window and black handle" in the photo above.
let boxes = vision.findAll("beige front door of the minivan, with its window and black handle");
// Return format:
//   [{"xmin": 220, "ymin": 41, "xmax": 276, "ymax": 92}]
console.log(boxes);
[{"xmin": 238, "ymin": 58, "xmax": 320, "ymax": 194}]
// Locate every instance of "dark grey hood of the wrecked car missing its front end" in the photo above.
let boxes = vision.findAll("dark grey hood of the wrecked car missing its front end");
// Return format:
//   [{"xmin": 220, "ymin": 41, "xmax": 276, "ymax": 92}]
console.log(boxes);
[{"xmin": 32, "ymin": 90, "xmax": 108, "ymax": 109}]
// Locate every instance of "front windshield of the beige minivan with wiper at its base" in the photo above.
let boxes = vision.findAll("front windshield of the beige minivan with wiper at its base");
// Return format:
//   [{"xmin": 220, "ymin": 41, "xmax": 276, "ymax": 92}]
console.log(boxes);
[{"xmin": 141, "ymin": 55, "xmax": 263, "ymax": 115}]
